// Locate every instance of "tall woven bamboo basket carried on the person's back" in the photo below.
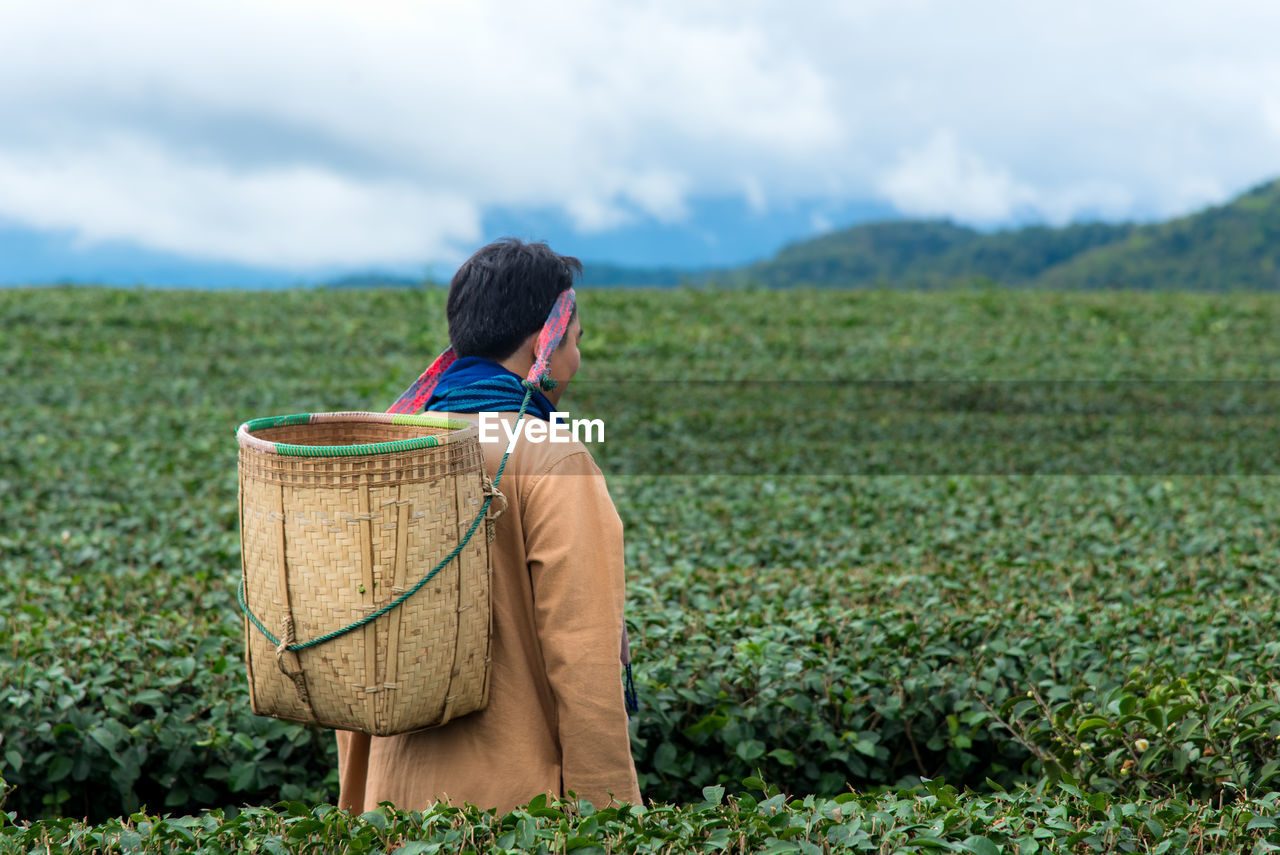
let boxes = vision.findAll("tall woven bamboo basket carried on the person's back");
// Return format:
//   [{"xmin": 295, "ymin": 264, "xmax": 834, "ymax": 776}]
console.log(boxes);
[{"xmin": 237, "ymin": 412, "xmax": 504, "ymax": 736}]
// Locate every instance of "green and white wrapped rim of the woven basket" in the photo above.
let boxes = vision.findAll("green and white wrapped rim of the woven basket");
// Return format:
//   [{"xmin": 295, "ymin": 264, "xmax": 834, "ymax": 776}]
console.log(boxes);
[{"xmin": 236, "ymin": 411, "xmax": 476, "ymax": 457}]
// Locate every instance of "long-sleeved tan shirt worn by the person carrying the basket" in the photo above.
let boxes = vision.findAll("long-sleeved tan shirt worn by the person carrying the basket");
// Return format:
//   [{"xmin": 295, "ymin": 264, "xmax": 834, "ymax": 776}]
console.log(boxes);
[{"xmin": 337, "ymin": 413, "xmax": 640, "ymax": 811}]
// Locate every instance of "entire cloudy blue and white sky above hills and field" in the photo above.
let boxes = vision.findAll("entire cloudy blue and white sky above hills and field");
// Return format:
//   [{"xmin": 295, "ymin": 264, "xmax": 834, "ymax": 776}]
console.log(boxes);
[{"xmin": 0, "ymin": 0, "xmax": 1280, "ymax": 283}]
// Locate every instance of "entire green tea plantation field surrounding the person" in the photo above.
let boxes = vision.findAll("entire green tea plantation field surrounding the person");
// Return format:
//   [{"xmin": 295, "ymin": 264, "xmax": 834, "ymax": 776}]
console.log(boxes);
[{"xmin": 0, "ymin": 288, "xmax": 1280, "ymax": 855}]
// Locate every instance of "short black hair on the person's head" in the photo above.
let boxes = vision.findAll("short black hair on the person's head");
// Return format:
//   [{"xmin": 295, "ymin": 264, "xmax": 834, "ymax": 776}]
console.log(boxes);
[{"xmin": 445, "ymin": 238, "xmax": 582, "ymax": 362}]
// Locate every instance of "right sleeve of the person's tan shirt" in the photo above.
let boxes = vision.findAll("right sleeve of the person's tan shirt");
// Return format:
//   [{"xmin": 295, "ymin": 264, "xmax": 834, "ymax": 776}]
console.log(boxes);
[{"xmin": 521, "ymin": 451, "xmax": 640, "ymax": 808}]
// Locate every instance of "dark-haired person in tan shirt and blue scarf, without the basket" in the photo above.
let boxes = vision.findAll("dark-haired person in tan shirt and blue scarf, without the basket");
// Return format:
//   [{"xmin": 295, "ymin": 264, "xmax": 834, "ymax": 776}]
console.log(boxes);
[{"xmin": 337, "ymin": 238, "xmax": 640, "ymax": 813}]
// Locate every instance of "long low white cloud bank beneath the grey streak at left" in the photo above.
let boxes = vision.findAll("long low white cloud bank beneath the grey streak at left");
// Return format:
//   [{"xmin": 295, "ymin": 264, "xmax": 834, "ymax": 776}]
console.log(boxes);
[{"xmin": 0, "ymin": 138, "xmax": 480, "ymax": 269}]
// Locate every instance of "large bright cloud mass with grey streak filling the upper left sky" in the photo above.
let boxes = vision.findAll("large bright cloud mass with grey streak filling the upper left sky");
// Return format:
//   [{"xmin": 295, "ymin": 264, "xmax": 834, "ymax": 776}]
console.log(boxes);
[{"xmin": 0, "ymin": 0, "xmax": 840, "ymax": 268}]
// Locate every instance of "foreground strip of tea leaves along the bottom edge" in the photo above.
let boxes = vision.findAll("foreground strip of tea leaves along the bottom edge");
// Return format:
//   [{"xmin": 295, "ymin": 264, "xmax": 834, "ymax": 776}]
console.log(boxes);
[{"xmin": 0, "ymin": 779, "xmax": 1280, "ymax": 855}]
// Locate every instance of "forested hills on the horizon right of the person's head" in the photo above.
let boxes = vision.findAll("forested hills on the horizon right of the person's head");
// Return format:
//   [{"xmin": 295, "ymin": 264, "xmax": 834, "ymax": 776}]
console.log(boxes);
[{"xmin": 606, "ymin": 179, "xmax": 1280, "ymax": 291}]
